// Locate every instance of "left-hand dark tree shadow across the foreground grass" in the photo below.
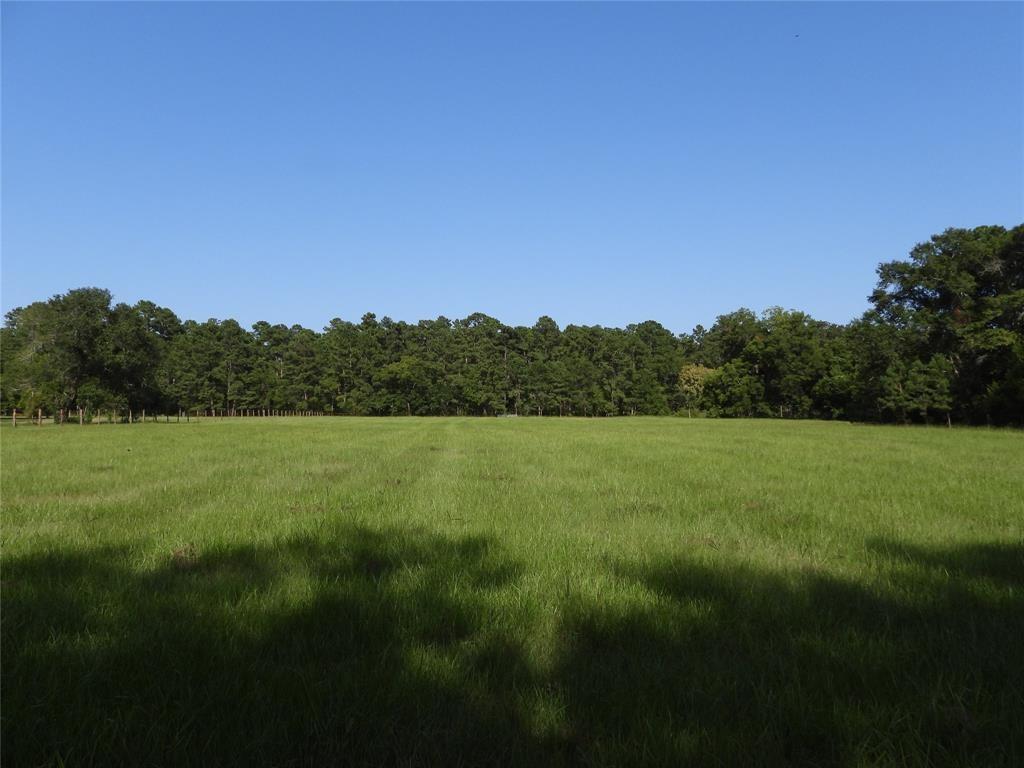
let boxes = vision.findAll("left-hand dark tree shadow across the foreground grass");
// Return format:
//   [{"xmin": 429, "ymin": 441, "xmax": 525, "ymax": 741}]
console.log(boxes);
[{"xmin": 3, "ymin": 526, "xmax": 542, "ymax": 765}]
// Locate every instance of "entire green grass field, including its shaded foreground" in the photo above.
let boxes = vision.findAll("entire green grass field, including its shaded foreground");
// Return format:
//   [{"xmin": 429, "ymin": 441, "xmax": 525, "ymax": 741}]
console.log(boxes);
[{"xmin": 0, "ymin": 418, "xmax": 1024, "ymax": 766}]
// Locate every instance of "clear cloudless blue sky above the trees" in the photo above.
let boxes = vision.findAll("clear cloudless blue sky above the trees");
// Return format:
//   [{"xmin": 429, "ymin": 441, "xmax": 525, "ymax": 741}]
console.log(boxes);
[{"xmin": 2, "ymin": 2, "xmax": 1024, "ymax": 332}]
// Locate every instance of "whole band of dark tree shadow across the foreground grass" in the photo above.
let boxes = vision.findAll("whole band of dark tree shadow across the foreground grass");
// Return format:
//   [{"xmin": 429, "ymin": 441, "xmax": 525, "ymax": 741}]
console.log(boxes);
[{"xmin": 3, "ymin": 527, "xmax": 1024, "ymax": 766}]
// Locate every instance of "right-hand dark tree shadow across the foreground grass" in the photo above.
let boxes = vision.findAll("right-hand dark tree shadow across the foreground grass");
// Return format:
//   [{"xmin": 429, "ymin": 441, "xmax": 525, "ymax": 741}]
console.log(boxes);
[{"xmin": 555, "ymin": 545, "xmax": 1024, "ymax": 766}]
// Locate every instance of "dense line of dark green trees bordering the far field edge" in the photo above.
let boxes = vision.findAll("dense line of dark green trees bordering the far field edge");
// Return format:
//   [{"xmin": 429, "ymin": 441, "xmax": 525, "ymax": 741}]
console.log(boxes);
[{"xmin": 0, "ymin": 224, "xmax": 1024, "ymax": 425}]
